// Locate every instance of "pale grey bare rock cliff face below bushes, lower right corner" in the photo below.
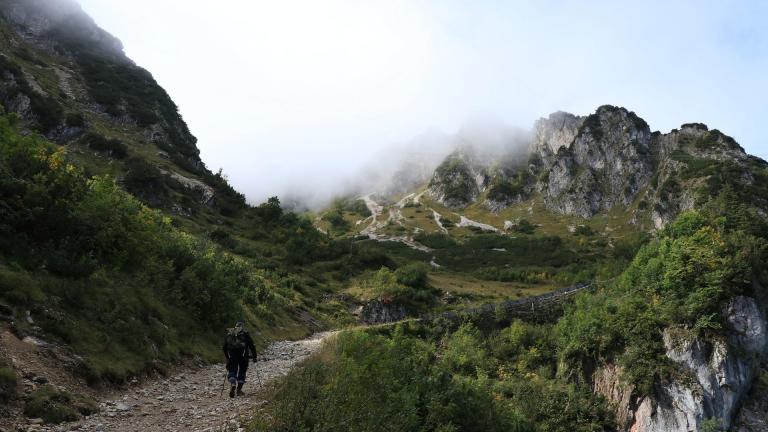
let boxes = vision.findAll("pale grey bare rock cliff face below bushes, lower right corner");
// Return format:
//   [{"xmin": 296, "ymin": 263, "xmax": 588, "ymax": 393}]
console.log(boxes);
[{"xmin": 593, "ymin": 296, "xmax": 768, "ymax": 432}]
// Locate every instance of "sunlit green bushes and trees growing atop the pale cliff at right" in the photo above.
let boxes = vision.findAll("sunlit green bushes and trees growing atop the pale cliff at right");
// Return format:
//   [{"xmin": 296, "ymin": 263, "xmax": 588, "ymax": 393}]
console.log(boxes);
[{"xmin": 557, "ymin": 202, "xmax": 768, "ymax": 394}]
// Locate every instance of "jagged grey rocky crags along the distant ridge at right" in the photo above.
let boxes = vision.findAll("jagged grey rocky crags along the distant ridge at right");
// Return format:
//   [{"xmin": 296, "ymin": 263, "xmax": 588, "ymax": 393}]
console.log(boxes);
[{"xmin": 427, "ymin": 105, "xmax": 768, "ymax": 229}]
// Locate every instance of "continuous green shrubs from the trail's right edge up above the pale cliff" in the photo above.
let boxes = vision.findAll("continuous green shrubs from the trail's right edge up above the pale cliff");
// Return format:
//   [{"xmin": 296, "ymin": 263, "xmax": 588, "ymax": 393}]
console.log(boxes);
[{"xmin": 253, "ymin": 198, "xmax": 768, "ymax": 431}]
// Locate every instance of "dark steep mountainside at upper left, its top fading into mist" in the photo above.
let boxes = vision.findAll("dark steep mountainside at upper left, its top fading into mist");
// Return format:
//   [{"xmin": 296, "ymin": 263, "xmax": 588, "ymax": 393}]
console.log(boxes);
[{"xmin": 0, "ymin": 0, "xmax": 245, "ymax": 221}]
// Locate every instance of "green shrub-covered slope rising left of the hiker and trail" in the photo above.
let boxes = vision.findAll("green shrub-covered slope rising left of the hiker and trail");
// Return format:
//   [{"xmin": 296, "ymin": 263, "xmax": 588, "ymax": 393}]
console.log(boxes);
[{"xmin": 0, "ymin": 118, "xmax": 295, "ymax": 381}]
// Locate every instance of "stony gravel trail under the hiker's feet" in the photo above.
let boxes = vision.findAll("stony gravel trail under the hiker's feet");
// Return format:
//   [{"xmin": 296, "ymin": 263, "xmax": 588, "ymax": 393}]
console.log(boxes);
[{"xmin": 0, "ymin": 332, "xmax": 335, "ymax": 432}]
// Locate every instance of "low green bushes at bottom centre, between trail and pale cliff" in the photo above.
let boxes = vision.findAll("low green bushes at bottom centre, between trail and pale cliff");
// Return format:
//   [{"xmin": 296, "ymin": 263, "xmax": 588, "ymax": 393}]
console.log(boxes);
[{"xmin": 254, "ymin": 322, "xmax": 612, "ymax": 431}]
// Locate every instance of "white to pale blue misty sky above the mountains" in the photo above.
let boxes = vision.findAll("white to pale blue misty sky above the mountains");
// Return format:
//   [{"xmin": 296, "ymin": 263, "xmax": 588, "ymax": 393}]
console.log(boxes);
[{"xmin": 79, "ymin": 0, "xmax": 768, "ymax": 202}]
